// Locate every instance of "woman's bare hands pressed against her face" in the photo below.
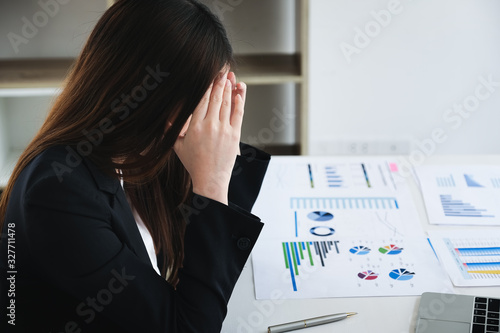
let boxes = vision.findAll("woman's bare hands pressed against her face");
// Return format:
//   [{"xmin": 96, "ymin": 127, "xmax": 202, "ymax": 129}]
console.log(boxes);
[{"xmin": 174, "ymin": 72, "xmax": 246, "ymax": 205}]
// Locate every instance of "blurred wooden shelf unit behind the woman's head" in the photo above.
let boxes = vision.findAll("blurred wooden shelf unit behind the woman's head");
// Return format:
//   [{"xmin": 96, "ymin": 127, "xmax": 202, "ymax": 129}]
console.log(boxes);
[{"xmin": 0, "ymin": 0, "xmax": 309, "ymax": 190}]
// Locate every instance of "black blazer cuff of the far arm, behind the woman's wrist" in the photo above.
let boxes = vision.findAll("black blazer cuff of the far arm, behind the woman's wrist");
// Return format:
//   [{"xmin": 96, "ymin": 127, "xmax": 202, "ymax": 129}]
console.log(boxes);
[{"xmin": 229, "ymin": 143, "xmax": 271, "ymax": 212}]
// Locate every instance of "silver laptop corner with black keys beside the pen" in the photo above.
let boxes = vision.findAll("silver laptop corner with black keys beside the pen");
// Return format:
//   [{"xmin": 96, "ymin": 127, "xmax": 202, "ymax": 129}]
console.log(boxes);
[{"xmin": 415, "ymin": 293, "xmax": 500, "ymax": 333}]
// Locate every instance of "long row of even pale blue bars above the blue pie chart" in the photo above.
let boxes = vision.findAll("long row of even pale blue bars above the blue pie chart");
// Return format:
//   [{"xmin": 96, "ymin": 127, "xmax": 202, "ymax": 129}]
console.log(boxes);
[{"xmin": 290, "ymin": 197, "xmax": 399, "ymax": 210}]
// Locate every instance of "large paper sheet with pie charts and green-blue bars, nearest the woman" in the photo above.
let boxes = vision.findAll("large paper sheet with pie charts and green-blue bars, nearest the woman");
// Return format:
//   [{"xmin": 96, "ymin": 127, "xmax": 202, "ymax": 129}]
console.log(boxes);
[{"xmin": 252, "ymin": 157, "xmax": 450, "ymax": 299}]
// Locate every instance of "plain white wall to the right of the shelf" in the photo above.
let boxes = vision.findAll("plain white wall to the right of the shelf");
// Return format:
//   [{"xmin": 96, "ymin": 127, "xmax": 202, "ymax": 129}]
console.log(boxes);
[{"xmin": 309, "ymin": 0, "xmax": 500, "ymax": 154}]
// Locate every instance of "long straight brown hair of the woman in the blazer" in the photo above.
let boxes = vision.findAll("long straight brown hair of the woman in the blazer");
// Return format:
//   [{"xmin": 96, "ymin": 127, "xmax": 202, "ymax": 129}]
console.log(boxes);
[{"xmin": 0, "ymin": 0, "xmax": 233, "ymax": 285}]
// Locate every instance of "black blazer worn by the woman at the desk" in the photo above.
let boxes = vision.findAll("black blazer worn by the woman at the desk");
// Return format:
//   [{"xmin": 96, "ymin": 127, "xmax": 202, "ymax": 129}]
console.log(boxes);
[{"xmin": 0, "ymin": 145, "xmax": 269, "ymax": 333}]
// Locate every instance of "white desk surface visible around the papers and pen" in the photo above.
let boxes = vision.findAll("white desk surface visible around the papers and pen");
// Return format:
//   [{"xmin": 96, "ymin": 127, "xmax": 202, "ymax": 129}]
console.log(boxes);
[{"xmin": 222, "ymin": 155, "xmax": 500, "ymax": 333}]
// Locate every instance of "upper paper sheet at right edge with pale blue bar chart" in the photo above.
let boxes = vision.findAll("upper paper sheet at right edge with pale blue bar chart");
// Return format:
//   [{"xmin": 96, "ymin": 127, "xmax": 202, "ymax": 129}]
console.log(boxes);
[{"xmin": 417, "ymin": 166, "xmax": 500, "ymax": 225}]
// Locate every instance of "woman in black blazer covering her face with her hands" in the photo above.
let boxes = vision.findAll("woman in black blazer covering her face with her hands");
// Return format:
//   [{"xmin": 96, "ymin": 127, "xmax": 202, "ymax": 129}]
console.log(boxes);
[{"xmin": 0, "ymin": 0, "xmax": 269, "ymax": 332}]
